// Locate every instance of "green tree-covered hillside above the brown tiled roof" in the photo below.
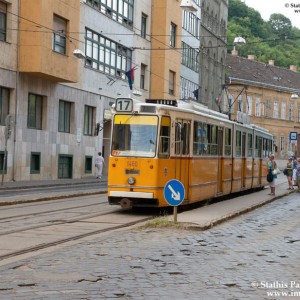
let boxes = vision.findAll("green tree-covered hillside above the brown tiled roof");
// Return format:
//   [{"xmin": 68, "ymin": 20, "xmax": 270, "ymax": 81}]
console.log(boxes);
[{"xmin": 227, "ymin": 0, "xmax": 300, "ymax": 68}]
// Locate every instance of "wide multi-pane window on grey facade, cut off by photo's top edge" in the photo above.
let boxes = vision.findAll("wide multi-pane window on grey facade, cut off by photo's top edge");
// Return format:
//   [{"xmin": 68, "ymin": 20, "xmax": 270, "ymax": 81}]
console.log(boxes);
[{"xmin": 86, "ymin": 0, "xmax": 134, "ymax": 27}]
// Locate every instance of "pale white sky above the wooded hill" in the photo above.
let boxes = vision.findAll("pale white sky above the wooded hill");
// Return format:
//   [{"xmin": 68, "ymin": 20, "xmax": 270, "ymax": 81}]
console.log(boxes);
[{"xmin": 242, "ymin": 0, "xmax": 300, "ymax": 29}]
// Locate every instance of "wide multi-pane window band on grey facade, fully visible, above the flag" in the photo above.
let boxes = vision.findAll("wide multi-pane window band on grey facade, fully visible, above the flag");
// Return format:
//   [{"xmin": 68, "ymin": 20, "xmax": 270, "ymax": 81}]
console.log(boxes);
[{"xmin": 85, "ymin": 29, "xmax": 132, "ymax": 80}]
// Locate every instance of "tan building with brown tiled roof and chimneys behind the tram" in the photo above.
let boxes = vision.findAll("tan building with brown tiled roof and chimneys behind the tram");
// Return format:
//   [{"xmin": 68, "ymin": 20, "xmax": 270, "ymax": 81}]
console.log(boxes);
[{"xmin": 225, "ymin": 52, "xmax": 300, "ymax": 159}]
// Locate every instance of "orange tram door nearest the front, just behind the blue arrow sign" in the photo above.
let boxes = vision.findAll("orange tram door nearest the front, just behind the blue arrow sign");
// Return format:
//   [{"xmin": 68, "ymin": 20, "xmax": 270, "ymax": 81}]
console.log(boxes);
[{"xmin": 175, "ymin": 119, "xmax": 191, "ymax": 199}]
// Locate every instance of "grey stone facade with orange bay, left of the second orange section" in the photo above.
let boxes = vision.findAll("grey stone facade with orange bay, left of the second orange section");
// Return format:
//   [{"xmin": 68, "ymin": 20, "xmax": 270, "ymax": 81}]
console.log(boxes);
[{"xmin": 0, "ymin": 0, "xmax": 151, "ymax": 181}]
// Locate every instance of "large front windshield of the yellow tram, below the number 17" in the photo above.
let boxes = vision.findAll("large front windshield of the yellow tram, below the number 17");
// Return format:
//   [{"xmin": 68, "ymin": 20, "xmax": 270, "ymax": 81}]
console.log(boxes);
[{"xmin": 111, "ymin": 115, "xmax": 158, "ymax": 157}]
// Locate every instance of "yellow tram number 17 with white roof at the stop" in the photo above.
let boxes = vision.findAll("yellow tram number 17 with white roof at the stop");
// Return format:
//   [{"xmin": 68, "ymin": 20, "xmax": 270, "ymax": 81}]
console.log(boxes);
[{"xmin": 108, "ymin": 98, "xmax": 272, "ymax": 208}]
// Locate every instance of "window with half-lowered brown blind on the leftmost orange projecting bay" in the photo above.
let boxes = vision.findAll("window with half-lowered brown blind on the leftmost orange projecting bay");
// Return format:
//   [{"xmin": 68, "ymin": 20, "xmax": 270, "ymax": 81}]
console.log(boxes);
[{"xmin": 52, "ymin": 15, "xmax": 67, "ymax": 54}]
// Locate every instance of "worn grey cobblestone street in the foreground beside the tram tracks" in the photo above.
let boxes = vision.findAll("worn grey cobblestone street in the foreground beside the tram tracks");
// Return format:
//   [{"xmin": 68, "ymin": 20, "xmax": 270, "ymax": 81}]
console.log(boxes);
[{"xmin": 0, "ymin": 193, "xmax": 300, "ymax": 300}]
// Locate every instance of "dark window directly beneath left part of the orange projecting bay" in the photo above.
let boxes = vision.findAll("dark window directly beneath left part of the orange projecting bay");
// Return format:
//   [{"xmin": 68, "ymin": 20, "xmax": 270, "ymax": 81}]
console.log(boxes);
[{"xmin": 27, "ymin": 94, "xmax": 43, "ymax": 129}]
